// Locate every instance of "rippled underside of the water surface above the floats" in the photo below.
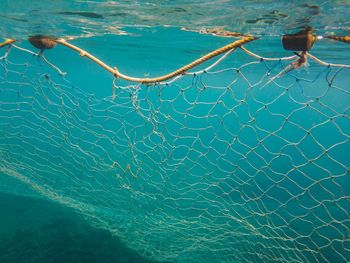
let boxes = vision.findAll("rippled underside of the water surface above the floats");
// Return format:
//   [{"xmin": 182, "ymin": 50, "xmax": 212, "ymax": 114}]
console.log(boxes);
[{"xmin": 0, "ymin": 0, "xmax": 349, "ymax": 37}]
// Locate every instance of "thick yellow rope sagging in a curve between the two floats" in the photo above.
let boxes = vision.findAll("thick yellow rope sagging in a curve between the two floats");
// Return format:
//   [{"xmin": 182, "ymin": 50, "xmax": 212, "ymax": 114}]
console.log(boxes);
[{"xmin": 55, "ymin": 36, "xmax": 257, "ymax": 84}]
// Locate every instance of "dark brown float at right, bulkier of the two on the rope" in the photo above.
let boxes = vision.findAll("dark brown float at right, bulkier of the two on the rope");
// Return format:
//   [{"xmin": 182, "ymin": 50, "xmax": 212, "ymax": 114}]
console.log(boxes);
[{"xmin": 282, "ymin": 27, "xmax": 316, "ymax": 51}]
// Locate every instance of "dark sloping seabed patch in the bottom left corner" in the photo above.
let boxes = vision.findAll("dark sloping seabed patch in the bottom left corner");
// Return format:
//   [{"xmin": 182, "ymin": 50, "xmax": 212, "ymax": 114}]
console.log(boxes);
[{"xmin": 0, "ymin": 193, "xmax": 163, "ymax": 263}]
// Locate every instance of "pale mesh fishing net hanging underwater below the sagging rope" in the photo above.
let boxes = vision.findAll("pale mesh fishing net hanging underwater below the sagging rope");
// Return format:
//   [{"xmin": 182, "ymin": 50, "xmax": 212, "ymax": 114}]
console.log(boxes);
[{"xmin": 0, "ymin": 34, "xmax": 350, "ymax": 262}]
